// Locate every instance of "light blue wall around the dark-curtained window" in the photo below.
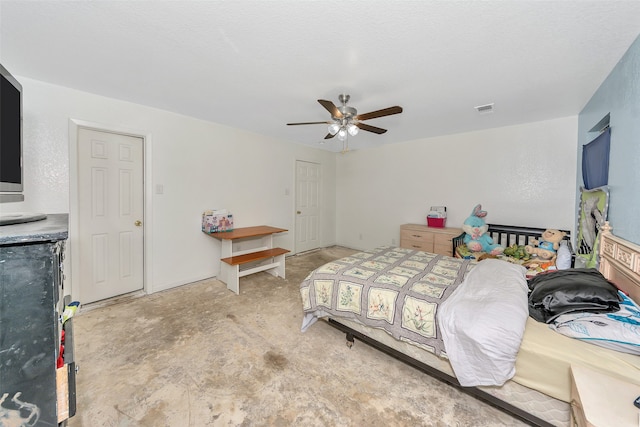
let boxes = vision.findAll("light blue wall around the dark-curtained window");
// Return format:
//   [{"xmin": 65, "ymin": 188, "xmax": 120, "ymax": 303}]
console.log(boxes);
[{"xmin": 576, "ymin": 37, "xmax": 640, "ymax": 244}]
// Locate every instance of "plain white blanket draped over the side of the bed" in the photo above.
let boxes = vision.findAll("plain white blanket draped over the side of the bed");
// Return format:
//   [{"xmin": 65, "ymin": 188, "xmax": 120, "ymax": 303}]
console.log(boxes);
[{"xmin": 438, "ymin": 259, "xmax": 529, "ymax": 387}]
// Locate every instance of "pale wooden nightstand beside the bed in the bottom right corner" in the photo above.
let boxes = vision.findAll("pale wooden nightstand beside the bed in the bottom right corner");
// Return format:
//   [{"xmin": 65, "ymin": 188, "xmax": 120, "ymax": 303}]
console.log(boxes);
[{"xmin": 571, "ymin": 365, "xmax": 640, "ymax": 427}]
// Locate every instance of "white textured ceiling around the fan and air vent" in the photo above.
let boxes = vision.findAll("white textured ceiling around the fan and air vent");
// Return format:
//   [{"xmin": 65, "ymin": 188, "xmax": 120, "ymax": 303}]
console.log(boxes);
[{"xmin": 0, "ymin": 0, "xmax": 640, "ymax": 151}]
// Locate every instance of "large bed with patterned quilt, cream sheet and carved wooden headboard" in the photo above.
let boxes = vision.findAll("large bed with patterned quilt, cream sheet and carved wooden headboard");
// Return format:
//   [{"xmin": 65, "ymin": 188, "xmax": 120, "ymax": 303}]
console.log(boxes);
[{"xmin": 300, "ymin": 225, "xmax": 640, "ymax": 426}]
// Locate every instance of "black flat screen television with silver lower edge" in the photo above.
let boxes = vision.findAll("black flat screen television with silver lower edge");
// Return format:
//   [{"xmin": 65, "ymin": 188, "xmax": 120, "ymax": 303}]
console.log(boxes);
[{"xmin": 0, "ymin": 64, "xmax": 24, "ymax": 203}]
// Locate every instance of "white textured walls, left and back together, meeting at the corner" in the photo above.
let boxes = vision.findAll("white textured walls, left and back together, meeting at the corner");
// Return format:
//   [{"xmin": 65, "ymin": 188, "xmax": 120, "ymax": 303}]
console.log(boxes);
[{"xmin": 2, "ymin": 78, "xmax": 577, "ymax": 300}]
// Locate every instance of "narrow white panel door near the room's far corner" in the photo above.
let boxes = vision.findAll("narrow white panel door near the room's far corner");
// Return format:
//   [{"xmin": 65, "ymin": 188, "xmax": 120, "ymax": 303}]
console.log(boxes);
[{"xmin": 296, "ymin": 160, "xmax": 321, "ymax": 253}]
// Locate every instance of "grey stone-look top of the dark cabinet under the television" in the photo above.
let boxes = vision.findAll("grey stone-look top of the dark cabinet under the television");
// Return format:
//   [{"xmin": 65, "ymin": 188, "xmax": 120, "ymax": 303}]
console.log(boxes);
[{"xmin": 0, "ymin": 214, "xmax": 69, "ymax": 246}]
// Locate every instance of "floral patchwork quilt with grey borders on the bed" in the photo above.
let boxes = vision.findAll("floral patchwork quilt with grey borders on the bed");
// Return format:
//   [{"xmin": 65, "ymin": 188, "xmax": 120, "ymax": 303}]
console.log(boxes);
[{"xmin": 300, "ymin": 246, "xmax": 476, "ymax": 356}]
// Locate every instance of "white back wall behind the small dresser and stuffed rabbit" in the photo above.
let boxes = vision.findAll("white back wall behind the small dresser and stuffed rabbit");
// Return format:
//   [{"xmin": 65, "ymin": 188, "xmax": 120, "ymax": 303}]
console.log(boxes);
[{"xmin": 336, "ymin": 116, "xmax": 577, "ymax": 249}]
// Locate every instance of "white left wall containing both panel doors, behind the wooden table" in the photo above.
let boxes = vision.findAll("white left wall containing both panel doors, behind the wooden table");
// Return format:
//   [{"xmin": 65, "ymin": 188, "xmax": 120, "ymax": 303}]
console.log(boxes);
[{"xmin": 7, "ymin": 77, "xmax": 336, "ymax": 301}]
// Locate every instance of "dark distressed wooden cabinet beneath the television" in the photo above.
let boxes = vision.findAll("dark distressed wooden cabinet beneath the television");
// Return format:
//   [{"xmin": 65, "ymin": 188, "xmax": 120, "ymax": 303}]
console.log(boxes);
[{"xmin": 0, "ymin": 215, "xmax": 75, "ymax": 426}]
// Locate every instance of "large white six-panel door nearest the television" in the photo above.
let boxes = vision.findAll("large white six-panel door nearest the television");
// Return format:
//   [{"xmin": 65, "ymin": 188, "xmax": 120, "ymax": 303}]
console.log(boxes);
[{"xmin": 78, "ymin": 128, "xmax": 144, "ymax": 304}]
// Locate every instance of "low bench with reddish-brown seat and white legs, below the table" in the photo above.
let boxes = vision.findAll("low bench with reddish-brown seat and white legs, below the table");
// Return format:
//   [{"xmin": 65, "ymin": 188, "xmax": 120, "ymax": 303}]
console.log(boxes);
[{"xmin": 220, "ymin": 248, "xmax": 289, "ymax": 294}]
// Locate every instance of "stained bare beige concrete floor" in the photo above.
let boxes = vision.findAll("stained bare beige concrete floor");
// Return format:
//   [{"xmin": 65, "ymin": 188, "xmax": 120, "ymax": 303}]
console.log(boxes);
[{"xmin": 68, "ymin": 248, "xmax": 523, "ymax": 427}]
